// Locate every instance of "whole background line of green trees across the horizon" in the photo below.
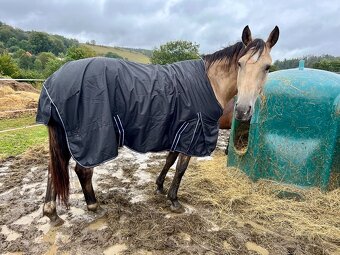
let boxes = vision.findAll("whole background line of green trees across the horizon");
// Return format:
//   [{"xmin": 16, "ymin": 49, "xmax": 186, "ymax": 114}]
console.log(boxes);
[{"xmin": 0, "ymin": 22, "xmax": 340, "ymax": 79}]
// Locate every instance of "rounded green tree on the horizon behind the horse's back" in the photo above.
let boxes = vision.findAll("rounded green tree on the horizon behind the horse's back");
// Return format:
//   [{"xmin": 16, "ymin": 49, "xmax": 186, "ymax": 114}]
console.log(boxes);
[{"xmin": 151, "ymin": 41, "xmax": 200, "ymax": 65}]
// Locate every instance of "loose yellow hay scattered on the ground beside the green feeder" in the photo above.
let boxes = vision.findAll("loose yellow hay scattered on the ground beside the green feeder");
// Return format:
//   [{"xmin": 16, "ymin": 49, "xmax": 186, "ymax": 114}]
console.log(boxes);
[{"xmin": 181, "ymin": 151, "xmax": 340, "ymax": 253}]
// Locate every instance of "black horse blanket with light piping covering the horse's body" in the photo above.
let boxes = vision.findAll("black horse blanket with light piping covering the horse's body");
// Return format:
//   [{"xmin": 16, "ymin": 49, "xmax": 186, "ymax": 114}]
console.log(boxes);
[{"xmin": 37, "ymin": 58, "xmax": 223, "ymax": 167}]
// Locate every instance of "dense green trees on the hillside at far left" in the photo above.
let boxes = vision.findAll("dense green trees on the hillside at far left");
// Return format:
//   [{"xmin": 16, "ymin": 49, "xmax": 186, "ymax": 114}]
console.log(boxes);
[{"xmin": 0, "ymin": 22, "xmax": 121, "ymax": 79}]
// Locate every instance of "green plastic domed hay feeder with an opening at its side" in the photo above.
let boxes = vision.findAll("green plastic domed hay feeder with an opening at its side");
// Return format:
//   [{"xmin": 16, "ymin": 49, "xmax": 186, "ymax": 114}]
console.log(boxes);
[{"xmin": 228, "ymin": 64, "xmax": 340, "ymax": 190}]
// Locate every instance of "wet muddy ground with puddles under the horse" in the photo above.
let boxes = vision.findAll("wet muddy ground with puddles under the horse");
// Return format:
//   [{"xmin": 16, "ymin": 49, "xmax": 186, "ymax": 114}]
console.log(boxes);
[{"xmin": 0, "ymin": 132, "xmax": 340, "ymax": 255}]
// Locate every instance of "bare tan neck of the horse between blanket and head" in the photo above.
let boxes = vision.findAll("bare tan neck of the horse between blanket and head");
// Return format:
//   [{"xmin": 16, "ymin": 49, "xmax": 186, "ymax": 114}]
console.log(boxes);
[{"xmin": 207, "ymin": 61, "xmax": 237, "ymax": 108}]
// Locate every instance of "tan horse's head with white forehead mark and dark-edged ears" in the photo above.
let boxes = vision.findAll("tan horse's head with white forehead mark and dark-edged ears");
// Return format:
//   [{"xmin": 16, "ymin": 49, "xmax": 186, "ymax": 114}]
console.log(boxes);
[{"xmin": 235, "ymin": 26, "xmax": 279, "ymax": 121}]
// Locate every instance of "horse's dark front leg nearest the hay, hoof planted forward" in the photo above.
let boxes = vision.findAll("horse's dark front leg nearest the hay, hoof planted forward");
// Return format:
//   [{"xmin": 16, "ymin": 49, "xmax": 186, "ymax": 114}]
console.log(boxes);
[{"xmin": 168, "ymin": 154, "xmax": 191, "ymax": 212}]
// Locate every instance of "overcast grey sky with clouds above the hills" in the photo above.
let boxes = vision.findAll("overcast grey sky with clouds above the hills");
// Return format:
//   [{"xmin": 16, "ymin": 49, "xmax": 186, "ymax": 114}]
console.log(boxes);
[{"xmin": 0, "ymin": 0, "xmax": 340, "ymax": 59}]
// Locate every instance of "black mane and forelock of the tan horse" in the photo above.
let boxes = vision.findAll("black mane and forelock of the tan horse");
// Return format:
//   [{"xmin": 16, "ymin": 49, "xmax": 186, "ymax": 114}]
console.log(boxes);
[{"xmin": 203, "ymin": 39, "xmax": 266, "ymax": 69}]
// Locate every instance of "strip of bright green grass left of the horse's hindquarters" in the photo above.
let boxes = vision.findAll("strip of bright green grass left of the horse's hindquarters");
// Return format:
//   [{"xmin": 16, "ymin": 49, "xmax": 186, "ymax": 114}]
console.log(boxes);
[{"xmin": 0, "ymin": 125, "xmax": 48, "ymax": 160}]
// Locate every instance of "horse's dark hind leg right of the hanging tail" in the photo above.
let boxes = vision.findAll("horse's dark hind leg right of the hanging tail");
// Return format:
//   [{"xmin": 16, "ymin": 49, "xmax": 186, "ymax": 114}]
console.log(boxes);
[{"xmin": 74, "ymin": 163, "xmax": 98, "ymax": 211}]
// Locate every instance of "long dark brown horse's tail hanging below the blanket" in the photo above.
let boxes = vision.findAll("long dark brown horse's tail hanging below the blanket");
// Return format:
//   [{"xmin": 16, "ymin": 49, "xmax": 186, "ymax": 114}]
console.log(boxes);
[{"xmin": 48, "ymin": 107, "xmax": 71, "ymax": 206}]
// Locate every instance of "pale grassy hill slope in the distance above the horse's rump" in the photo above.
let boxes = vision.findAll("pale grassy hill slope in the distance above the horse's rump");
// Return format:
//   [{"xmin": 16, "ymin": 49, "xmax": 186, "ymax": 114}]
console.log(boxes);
[{"xmin": 83, "ymin": 44, "xmax": 150, "ymax": 64}]
